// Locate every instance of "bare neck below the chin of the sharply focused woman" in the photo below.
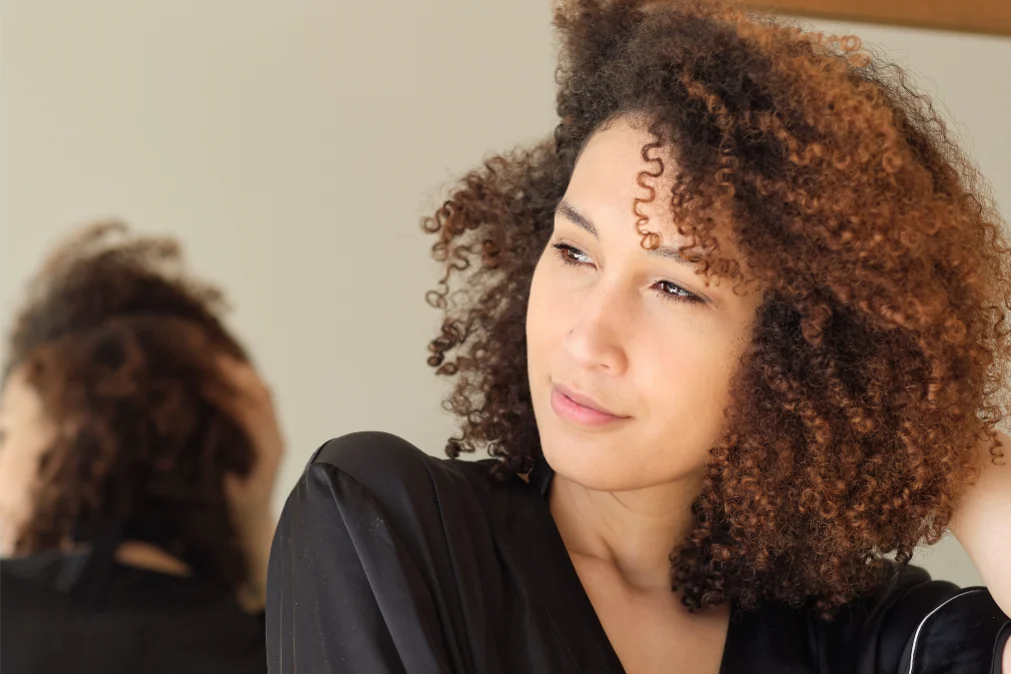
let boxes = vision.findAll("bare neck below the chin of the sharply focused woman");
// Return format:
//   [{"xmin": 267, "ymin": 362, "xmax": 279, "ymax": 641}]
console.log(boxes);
[{"xmin": 549, "ymin": 474, "xmax": 700, "ymax": 593}]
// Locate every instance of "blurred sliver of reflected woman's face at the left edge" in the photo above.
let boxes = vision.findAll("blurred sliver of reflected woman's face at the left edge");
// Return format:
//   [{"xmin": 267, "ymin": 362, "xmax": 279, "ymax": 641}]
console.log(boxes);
[{"xmin": 0, "ymin": 370, "xmax": 56, "ymax": 557}]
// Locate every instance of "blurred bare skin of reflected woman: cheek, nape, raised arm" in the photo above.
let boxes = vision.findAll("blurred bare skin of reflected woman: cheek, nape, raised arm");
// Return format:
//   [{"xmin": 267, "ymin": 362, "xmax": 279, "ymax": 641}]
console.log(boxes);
[{"xmin": 0, "ymin": 358, "xmax": 284, "ymax": 612}]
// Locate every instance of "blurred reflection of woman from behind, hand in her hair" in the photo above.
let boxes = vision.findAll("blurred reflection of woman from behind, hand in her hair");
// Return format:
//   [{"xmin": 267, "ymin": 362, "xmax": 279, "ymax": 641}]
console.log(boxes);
[{"xmin": 0, "ymin": 223, "xmax": 282, "ymax": 674}]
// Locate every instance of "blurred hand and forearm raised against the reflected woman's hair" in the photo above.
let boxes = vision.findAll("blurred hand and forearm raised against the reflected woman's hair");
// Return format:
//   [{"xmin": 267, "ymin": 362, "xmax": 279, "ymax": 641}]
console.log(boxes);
[{"xmin": 207, "ymin": 356, "xmax": 284, "ymax": 612}]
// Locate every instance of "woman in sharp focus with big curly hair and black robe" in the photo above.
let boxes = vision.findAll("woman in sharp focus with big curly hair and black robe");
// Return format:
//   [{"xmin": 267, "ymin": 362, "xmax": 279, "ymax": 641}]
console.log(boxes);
[{"xmin": 267, "ymin": 0, "xmax": 1011, "ymax": 674}]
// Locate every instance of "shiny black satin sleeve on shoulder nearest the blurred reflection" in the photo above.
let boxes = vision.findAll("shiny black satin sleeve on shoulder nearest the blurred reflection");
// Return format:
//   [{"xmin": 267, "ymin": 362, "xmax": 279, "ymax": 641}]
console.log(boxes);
[{"xmin": 266, "ymin": 437, "xmax": 453, "ymax": 674}]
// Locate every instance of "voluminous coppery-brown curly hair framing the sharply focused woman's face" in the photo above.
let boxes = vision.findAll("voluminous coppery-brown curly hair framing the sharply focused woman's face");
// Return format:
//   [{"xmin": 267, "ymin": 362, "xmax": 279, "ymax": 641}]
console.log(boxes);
[{"xmin": 423, "ymin": 0, "xmax": 1011, "ymax": 616}]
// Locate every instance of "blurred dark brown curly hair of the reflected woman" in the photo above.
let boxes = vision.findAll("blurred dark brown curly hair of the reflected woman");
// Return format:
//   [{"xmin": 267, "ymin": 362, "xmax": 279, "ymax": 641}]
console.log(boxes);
[{"xmin": 4, "ymin": 222, "xmax": 254, "ymax": 589}]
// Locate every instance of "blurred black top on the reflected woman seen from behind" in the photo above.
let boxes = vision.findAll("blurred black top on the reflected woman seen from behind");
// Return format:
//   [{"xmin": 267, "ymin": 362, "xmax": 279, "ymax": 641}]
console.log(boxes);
[{"xmin": 0, "ymin": 553, "xmax": 267, "ymax": 674}]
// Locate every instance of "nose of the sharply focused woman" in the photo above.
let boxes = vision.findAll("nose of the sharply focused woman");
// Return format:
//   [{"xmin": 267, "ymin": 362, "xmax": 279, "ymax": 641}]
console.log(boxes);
[{"xmin": 564, "ymin": 284, "xmax": 632, "ymax": 375}]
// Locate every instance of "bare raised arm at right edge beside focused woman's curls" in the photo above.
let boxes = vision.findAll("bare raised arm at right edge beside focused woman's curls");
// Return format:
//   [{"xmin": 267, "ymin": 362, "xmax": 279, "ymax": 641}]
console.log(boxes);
[{"xmin": 949, "ymin": 432, "xmax": 1011, "ymax": 673}]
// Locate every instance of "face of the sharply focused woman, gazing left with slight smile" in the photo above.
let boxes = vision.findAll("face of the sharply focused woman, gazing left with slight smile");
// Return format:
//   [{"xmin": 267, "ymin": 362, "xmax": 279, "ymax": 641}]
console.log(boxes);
[{"xmin": 527, "ymin": 121, "xmax": 761, "ymax": 491}]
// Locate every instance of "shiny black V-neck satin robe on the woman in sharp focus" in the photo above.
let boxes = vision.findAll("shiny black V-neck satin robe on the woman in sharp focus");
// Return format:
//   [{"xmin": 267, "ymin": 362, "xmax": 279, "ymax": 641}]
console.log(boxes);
[{"xmin": 267, "ymin": 432, "xmax": 1009, "ymax": 674}]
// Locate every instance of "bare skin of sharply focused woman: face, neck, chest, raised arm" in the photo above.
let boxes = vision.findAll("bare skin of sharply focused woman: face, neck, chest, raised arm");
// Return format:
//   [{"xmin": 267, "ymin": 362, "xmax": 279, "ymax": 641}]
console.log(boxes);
[{"xmin": 527, "ymin": 119, "xmax": 1011, "ymax": 674}]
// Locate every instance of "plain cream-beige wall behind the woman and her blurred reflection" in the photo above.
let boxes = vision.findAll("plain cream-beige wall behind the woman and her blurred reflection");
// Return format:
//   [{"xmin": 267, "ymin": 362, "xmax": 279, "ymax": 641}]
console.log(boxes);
[{"xmin": 0, "ymin": 0, "xmax": 1011, "ymax": 583}]
